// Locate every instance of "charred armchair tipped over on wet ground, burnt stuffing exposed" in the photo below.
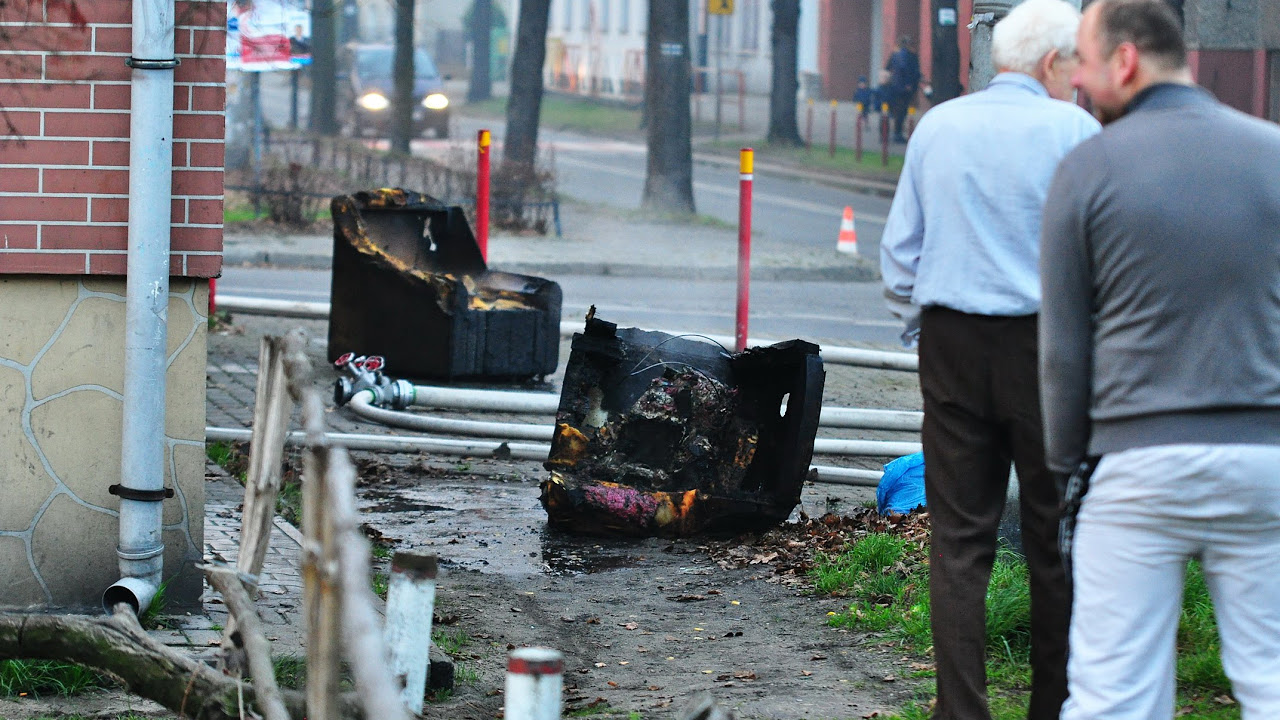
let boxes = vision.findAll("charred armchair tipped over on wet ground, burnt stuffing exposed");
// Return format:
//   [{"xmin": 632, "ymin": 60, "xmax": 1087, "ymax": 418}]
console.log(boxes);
[{"xmin": 541, "ymin": 319, "xmax": 826, "ymax": 536}]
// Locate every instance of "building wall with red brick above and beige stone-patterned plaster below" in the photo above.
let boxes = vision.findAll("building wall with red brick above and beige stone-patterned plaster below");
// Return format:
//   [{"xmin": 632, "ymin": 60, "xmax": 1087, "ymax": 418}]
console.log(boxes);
[{"xmin": 0, "ymin": 0, "xmax": 227, "ymax": 609}]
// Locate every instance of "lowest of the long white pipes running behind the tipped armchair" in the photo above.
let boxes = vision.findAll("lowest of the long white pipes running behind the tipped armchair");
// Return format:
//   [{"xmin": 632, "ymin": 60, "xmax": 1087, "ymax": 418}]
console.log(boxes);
[{"xmin": 205, "ymin": 427, "xmax": 879, "ymax": 487}]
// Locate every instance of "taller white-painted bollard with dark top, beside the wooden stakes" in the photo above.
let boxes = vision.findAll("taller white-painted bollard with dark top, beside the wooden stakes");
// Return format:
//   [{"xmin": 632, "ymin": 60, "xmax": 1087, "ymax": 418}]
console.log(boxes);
[{"xmin": 387, "ymin": 552, "xmax": 436, "ymax": 715}]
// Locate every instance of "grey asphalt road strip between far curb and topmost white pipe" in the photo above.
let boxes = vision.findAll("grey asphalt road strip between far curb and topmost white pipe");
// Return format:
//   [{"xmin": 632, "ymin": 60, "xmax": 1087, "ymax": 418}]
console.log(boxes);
[{"xmin": 218, "ymin": 266, "xmax": 899, "ymax": 350}]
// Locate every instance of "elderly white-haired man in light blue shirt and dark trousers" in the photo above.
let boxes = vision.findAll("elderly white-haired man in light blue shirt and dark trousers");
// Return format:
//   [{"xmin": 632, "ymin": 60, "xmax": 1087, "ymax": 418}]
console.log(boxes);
[{"xmin": 881, "ymin": 0, "xmax": 1100, "ymax": 720}]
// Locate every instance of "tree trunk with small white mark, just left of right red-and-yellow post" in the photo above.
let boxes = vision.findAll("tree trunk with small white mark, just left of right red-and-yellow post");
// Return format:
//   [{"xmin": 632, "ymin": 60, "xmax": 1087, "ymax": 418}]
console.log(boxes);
[{"xmin": 641, "ymin": 0, "xmax": 695, "ymax": 215}]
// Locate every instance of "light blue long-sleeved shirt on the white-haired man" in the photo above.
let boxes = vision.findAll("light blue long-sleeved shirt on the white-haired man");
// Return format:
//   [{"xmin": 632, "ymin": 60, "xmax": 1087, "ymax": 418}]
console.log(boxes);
[{"xmin": 881, "ymin": 73, "xmax": 1101, "ymax": 315}]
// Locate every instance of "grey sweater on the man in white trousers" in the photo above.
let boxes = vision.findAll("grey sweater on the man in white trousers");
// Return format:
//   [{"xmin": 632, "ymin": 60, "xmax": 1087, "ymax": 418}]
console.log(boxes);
[{"xmin": 1039, "ymin": 85, "xmax": 1280, "ymax": 477}]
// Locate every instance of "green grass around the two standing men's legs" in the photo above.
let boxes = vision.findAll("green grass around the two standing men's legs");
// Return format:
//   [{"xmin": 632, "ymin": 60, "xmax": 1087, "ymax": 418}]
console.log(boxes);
[{"xmin": 812, "ymin": 534, "xmax": 1240, "ymax": 720}]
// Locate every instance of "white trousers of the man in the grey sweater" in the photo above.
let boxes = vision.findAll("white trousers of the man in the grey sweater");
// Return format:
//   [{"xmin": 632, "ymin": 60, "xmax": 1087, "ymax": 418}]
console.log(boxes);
[{"xmin": 1061, "ymin": 445, "xmax": 1280, "ymax": 720}]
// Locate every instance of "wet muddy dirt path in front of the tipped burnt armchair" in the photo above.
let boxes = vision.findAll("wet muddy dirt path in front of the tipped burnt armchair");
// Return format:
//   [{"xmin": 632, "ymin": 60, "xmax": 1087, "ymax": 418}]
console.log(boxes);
[{"xmin": 360, "ymin": 456, "xmax": 931, "ymax": 719}]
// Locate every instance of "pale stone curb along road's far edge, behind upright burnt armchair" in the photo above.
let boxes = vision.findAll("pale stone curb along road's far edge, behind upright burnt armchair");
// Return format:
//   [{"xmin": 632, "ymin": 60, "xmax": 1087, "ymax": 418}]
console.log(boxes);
[{"xmin": 223, "ymin": 251, "xmax": 879, "ymax": 282}]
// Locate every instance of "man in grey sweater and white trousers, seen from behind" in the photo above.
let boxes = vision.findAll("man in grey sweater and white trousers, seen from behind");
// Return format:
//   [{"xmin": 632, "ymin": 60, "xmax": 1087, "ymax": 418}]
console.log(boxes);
[{"xmin": 1039, "ymin": 0, "xmax": 1280, "ymax": 720}]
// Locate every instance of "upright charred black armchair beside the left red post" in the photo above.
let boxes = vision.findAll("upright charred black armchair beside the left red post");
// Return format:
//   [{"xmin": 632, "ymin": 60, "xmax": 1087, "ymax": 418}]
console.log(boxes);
[{"xmin": 329, "ymin": 188, "xmax": 562, "ymax": 379}]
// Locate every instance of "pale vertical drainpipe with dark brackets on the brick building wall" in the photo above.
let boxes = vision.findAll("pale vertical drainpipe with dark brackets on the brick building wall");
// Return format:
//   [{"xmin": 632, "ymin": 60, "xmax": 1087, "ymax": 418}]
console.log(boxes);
[{"xmin": 102, "ymin": 0, "xmax": 178, "ymax": 614}]
